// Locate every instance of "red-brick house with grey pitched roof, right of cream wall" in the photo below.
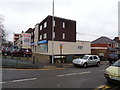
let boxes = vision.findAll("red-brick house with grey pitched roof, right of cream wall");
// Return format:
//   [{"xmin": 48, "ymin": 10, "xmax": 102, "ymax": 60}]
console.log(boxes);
[{"xmin": 91, "ymin": 36, "xmax": 117, "ymax": 60}]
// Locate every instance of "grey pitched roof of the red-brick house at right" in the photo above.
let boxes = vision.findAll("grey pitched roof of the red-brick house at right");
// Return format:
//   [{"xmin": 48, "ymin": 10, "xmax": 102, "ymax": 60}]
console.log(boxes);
[{"xmin": 91, "ymin": 36, "xmax": 115, "ymax": 44}]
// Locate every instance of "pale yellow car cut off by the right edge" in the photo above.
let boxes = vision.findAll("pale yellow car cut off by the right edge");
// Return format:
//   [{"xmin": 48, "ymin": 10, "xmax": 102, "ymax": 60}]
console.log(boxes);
[{"xmin": 104, "ymin": 59, "xmax": 120, "ymax": 83}]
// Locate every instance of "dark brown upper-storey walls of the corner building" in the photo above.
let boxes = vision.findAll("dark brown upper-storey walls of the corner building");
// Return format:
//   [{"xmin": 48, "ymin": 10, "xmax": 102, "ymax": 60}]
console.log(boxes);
[{"xmin": 38, "ymin": 16, "xmax": 76, "ymax": 42}]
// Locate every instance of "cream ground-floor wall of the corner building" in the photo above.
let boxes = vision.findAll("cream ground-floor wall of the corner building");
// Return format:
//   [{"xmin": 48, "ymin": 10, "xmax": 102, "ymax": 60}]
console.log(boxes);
[{"xmin": 37, "ymin": 41, "xmax": 91, "ymax": 55}]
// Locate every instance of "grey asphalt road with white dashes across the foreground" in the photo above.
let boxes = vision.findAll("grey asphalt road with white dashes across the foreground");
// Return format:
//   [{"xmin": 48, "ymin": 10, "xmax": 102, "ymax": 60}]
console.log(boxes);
[{"xmin": 0, "ymin": 65, "xmax": 119, "ymax": 89}]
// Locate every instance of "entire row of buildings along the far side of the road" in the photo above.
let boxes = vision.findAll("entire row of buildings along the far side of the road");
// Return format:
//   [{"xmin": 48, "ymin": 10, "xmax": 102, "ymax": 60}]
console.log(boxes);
[{"xmin": 14, "ymin": 15, "xmax": 119, "ymax": 62}]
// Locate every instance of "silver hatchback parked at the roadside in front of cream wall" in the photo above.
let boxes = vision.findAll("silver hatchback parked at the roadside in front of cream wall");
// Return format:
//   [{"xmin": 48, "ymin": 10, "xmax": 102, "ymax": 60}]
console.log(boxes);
[{"xmin": 73, "ymin": 55, "xmax": 100, "ymax": 67}]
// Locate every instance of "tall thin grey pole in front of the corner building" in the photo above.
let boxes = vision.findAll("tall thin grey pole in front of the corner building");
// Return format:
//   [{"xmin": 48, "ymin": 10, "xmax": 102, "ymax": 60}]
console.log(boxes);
[{"xmin": 52, "ymin": 0, "xmax": 54, "ymax": 64}]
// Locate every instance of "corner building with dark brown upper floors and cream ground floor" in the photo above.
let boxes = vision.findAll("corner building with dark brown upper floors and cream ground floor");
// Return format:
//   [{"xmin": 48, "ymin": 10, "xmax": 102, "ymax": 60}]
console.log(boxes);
[{"xmin": 16, "ymin": 15, "xmax": 91, "ymax": 60}]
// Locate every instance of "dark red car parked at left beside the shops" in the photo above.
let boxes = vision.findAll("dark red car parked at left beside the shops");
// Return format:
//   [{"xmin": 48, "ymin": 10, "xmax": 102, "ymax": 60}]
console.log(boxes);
[{"xmin": 11, "ymin": 48, "xmax": 32, "ymax": 57}]
